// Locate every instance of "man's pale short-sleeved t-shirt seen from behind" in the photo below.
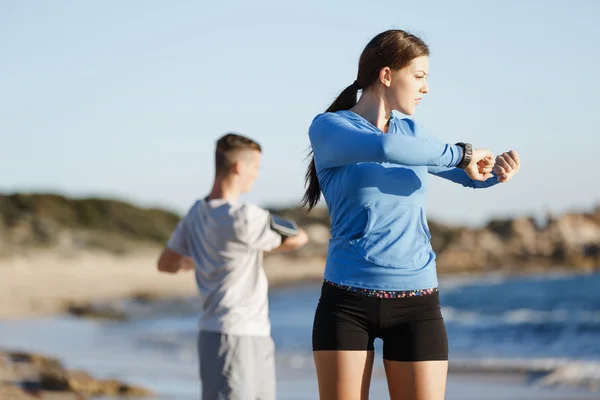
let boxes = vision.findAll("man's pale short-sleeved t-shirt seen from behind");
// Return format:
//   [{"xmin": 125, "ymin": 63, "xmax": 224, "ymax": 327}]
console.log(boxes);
[{"xmin": 167, "ymin": 199, "xmax": 281, "ymax": 336}]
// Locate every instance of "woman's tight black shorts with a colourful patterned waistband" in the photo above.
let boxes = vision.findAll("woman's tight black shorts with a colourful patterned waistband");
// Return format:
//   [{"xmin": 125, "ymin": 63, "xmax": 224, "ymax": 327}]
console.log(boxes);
[{"xmin": 312, "ymin": 282, "xmax": 448, "ymax": 361}]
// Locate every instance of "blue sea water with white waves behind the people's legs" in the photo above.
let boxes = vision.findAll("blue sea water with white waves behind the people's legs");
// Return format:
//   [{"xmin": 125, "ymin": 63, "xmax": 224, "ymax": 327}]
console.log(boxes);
[{"xmin": 0, "ymin": 273, "xmax": 600, "ymax": 400}]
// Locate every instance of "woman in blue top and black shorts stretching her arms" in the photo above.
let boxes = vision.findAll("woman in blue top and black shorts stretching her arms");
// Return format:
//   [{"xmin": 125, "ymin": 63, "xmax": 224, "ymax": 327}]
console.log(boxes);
[{"xmin": 303, "ymin": 30, "xmax": 519, "ymax": 400}]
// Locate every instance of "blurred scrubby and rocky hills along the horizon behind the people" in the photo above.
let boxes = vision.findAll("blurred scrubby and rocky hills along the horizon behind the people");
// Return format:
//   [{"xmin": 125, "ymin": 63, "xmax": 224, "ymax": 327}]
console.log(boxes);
[{"xmin": 0, "ymin": 194, "xmax": 600, "ymax": 273}]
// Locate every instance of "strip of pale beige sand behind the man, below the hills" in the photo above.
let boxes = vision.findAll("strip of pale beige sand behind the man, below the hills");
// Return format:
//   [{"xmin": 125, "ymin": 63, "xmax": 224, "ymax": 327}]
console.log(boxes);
[{"xmin": 0, "ymin": 249, "xmax": 323, "ymax": 318}]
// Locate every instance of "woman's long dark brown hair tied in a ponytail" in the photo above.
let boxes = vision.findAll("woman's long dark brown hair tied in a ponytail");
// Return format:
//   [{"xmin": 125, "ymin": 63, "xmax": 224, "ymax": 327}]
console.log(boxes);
[{"xmin": 302, "ymin": 30, "xmax": 429, "ymax": 211}]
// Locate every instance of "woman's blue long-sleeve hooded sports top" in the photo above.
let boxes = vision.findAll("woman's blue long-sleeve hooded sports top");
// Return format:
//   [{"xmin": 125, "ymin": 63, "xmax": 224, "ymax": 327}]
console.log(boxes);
[{"xmin": 308, "ymin": 110, "xmax": 498, "ymax": 290}]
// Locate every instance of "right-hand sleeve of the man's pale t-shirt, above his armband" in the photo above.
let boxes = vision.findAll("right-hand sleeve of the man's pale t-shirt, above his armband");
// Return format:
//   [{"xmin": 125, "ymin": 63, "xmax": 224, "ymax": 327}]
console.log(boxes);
[{"xmin": 240, "ymin": 204, "xmax": 282, "ymax": 251}]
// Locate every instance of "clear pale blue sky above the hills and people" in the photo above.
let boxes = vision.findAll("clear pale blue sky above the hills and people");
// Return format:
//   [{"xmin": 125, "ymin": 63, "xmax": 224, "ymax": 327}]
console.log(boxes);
[{"xmin": 0, "ymin": 0, "xmax": 600, "ymax": 224}]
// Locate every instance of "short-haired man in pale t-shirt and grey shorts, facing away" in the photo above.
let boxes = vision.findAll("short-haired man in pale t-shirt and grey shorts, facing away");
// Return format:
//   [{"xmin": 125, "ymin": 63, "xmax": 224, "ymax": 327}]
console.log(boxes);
[{"xmin": 158, "ymin": 134, "xmax": 308, "ymax": 400}]
